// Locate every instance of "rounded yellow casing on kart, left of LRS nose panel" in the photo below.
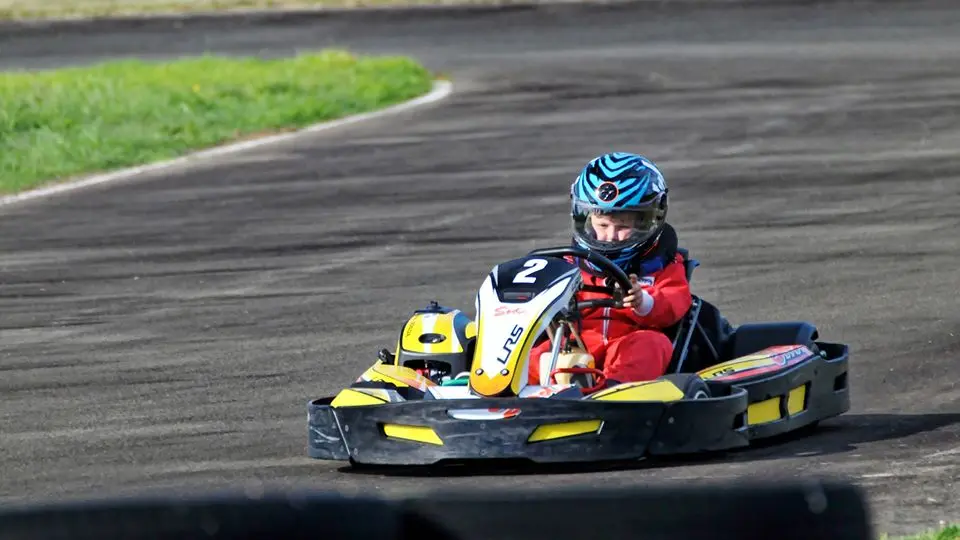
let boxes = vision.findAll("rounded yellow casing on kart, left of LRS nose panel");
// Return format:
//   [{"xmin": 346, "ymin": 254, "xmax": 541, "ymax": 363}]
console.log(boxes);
[{"xmin": 394, "ymin": 302, "xmax": 477, "ymax": 382}]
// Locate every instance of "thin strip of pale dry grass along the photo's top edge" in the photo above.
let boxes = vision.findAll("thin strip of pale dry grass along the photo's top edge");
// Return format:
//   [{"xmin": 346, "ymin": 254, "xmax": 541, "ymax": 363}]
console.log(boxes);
[{"xmin": 0, "ymin": 0, "xmax": 532, "ymax": 20}]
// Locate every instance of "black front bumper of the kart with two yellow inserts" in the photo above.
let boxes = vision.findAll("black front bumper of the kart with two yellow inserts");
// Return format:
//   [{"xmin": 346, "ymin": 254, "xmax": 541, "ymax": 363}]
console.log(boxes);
[{"xmin": 308, "ymin": 385, "xmax": 748, "ymax": 465}]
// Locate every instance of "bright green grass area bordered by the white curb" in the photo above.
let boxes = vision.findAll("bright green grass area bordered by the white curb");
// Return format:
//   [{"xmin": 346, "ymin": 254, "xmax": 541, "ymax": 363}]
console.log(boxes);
[{"xmin": 0, "ymin": 50, "xmax": 433, "ymax": 194}]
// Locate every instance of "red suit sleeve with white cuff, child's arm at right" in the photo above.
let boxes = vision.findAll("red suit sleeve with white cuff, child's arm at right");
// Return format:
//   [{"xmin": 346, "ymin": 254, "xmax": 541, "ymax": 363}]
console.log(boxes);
[{"xmin": 622, "ymin": 254, "xmax": 693, "ymax": 329}]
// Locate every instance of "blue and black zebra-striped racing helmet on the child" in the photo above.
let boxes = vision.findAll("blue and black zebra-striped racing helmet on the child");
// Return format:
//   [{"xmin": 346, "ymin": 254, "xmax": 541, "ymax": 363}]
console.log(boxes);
[{"xmin": 570, "ymin": 152, "xmax": 667, "ymax": 271}]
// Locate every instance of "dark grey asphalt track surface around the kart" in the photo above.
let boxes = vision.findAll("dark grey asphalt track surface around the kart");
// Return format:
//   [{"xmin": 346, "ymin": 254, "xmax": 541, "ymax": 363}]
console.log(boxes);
[{"xmin": 0, "ymin": 1, "xmax": 960, "ymax": 534}]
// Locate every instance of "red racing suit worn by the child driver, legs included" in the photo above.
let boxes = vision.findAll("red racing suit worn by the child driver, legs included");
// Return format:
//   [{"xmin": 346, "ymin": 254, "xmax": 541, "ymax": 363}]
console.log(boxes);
[{"xmin": 528, "ymin": 253, "xmax": 692, "ymax": 384}]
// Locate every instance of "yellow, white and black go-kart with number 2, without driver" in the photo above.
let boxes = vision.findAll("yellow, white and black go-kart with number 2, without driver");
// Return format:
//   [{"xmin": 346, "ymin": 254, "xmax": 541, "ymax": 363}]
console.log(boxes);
[{"xmin": 308, "ymin": 243, "xmax": 850, "ymax": 466}]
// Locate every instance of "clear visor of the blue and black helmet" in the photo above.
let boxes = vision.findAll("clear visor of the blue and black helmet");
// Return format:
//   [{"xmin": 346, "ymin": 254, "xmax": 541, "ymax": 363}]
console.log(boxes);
[{"xmin": 572, "ymin": 202, "xmax": 664, "ymax": 253}]
